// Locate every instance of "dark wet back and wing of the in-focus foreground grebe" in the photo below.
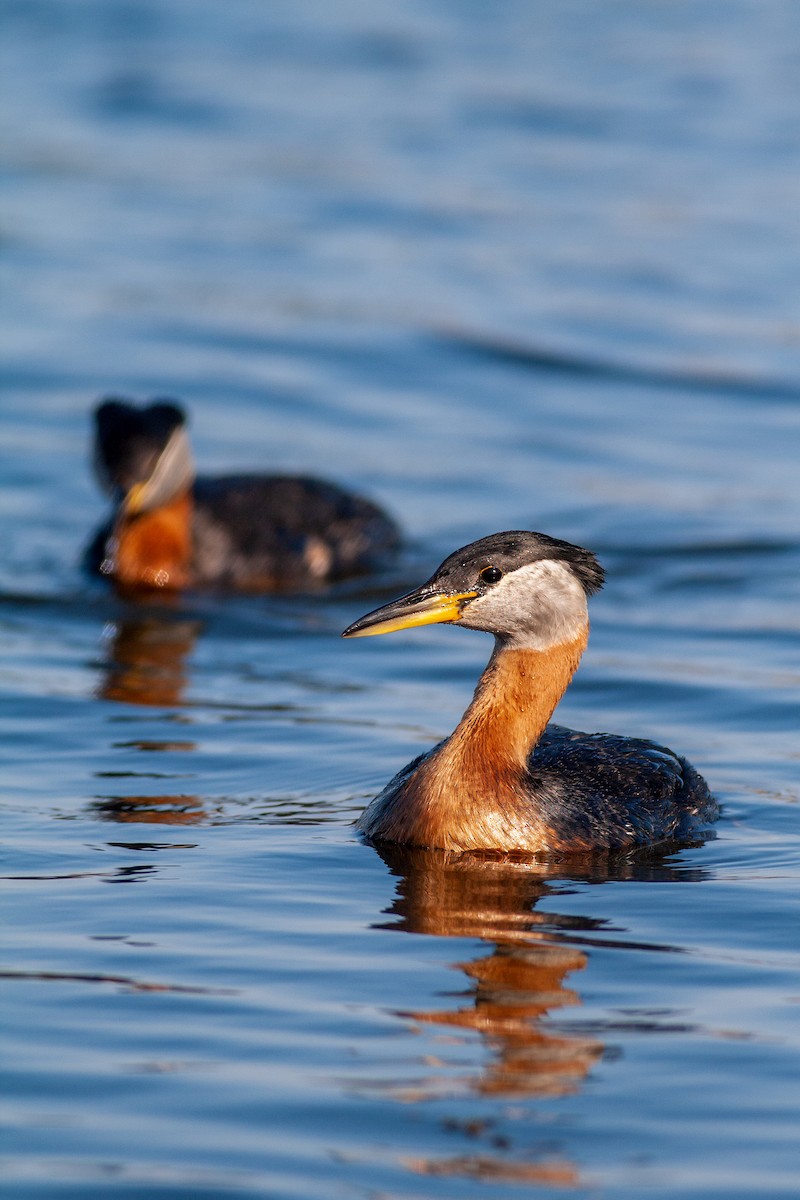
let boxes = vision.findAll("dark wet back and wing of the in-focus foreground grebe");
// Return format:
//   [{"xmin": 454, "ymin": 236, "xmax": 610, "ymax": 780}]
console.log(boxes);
[{"xmin": 528, "ymin": 725, "xmax": 717, "ymax": 848}]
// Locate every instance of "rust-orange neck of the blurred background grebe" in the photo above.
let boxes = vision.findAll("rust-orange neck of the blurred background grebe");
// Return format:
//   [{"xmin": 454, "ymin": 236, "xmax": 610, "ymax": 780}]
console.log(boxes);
[{"xmin": 114, "ymin": 491, "xmax": 192, "ymax": 590}]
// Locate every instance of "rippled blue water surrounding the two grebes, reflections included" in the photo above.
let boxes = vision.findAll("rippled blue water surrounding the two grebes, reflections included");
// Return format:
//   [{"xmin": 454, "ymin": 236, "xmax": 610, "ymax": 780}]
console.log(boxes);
[{"xmin": 0, "ymin": 0, "xmax": 800, "ymax": 1200}]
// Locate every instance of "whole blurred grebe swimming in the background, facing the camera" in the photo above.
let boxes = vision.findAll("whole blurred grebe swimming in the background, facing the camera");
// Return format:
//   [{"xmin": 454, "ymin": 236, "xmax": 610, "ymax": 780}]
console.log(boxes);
[{"xmin": 86, "ymin": 397, "xmax": 399, "ymax": 592}]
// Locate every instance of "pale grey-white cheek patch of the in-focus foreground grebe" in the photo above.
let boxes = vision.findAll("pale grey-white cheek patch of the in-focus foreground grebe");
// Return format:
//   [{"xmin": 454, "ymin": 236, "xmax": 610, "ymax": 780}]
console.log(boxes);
[{"xmin": 458, "ymin": 559, "xmax": 588, "ymax": 650}]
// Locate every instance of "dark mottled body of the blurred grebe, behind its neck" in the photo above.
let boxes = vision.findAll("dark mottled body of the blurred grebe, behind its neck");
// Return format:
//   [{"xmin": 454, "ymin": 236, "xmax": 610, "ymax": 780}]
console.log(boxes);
[{"xmin": 193, "ymin": 475, "xmax": 399, "ymax": 589}]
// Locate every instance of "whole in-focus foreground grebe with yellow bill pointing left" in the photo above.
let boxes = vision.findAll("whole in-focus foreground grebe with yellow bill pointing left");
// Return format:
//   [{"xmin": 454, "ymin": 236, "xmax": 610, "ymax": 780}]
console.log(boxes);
[{"xmin": 343, "ymin": 530, "xmax": 717, "ymax": 854}]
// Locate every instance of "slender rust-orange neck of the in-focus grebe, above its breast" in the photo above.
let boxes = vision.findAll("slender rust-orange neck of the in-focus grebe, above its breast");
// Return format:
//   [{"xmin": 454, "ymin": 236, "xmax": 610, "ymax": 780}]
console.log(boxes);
[{"xmin": 438, "ymin": 623, "xmax": 589, "ymax": 780}]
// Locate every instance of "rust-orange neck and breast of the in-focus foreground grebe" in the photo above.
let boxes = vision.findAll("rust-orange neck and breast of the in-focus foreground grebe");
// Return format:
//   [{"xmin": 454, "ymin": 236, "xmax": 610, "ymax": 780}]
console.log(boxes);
[{"xmin": 361, "ymin": 624, "xmax": 589, "ymax": 851}]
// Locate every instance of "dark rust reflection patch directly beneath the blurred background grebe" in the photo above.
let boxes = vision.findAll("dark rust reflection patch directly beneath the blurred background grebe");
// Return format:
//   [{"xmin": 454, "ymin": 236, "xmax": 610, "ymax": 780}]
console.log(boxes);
[{"xmin": 98, "ymin": 613, "xmax": 201, "ymax": 706}]
